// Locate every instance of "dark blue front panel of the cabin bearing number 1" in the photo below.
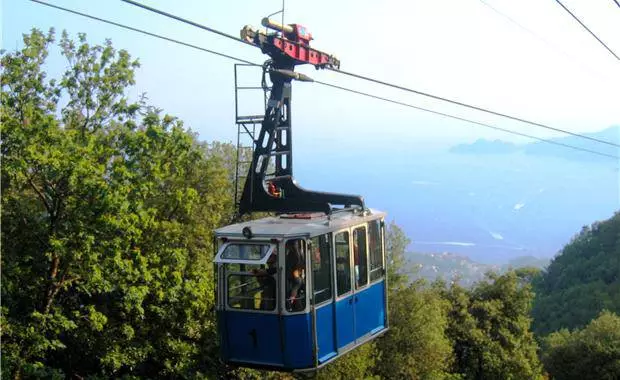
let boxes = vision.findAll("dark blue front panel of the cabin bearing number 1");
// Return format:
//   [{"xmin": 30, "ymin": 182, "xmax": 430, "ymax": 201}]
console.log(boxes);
[{"xmin": 220, "ymin": 310, "xmax": 284, "ymax": 366}]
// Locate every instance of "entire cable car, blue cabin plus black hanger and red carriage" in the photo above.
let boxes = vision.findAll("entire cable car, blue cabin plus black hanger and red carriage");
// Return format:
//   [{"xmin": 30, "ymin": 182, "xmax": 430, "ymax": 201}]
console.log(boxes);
[{"xmin": 215, "ymin": 19, "xmax": 388, "ymax": 372}]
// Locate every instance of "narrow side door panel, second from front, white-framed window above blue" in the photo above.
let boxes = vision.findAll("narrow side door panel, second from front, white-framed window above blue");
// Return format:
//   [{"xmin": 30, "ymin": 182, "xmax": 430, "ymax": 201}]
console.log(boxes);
[{"xmin": 332, "ymin": 230, "xmax": 355, "ymax": 351}]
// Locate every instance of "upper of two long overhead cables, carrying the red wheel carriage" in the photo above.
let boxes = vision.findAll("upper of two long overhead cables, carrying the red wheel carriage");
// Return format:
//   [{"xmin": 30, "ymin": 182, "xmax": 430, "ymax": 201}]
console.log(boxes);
[{"xmin": 122, "ymin": 0, "xmax": 620, "ymax": 148}]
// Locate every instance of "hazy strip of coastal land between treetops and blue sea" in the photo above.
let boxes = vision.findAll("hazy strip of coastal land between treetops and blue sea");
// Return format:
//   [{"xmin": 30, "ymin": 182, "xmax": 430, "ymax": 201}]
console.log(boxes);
[{"xmin": 407, "ymin": 252, "xmax": 549, "ymax": 287}]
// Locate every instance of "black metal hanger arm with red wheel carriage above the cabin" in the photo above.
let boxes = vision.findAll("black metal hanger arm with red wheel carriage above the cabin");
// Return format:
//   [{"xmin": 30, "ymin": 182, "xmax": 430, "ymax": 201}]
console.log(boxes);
[{"xmin": 235, "ymin": 28, "xmax": 365, "ymax": 217}]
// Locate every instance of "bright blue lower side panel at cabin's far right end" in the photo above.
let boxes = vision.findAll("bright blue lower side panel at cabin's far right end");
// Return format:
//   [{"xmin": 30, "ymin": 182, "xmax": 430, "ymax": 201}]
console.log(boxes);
[{"xmin": 354, "ymin": 280, "xmax": 385, "ymax": 338}]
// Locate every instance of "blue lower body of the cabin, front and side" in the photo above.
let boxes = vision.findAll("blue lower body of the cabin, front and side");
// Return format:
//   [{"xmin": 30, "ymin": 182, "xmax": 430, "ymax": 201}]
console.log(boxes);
[{"xmin": 218, "ymin": 280, "xmax": 387, "ymax": 371}]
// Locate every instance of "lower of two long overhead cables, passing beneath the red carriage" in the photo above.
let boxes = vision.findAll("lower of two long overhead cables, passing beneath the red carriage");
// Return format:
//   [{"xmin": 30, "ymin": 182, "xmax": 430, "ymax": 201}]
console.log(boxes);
[{"xmin": 30, "ymin": 0, "xmax": 620, "ymax": 160}]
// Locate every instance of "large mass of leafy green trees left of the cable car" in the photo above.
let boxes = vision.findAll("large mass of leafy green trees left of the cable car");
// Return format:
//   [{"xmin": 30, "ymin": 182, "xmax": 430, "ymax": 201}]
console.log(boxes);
[{"xmin": 1, "ymin": 30, "xmax": 232, "ymax": 378}]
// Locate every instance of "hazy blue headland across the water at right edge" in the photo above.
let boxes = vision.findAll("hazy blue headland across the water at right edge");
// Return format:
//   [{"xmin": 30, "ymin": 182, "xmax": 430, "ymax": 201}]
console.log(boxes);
[{"xmin": 449, "ymin": 125, "xmax": 620, "ymax": 161}]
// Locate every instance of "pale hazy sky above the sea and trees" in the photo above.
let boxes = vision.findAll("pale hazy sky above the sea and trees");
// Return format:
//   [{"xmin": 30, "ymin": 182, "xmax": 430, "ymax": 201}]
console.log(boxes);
[{"xmin": 2, "ymin": 0, "xmax": 620, "ymax": 150}]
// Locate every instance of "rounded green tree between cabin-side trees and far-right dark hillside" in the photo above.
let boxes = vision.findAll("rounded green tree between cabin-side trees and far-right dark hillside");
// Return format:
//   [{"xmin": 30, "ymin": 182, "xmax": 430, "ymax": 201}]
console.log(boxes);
[{"xmin": 444, "ymin": 271, "xmax": 541, "ymax": 379}]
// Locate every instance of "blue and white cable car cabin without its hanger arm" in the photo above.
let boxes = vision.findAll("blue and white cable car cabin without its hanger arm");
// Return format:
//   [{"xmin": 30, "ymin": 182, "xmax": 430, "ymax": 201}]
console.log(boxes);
[{"xmin": 215, "ymin": 208, "xmax": 388, "ymax": 371}]
